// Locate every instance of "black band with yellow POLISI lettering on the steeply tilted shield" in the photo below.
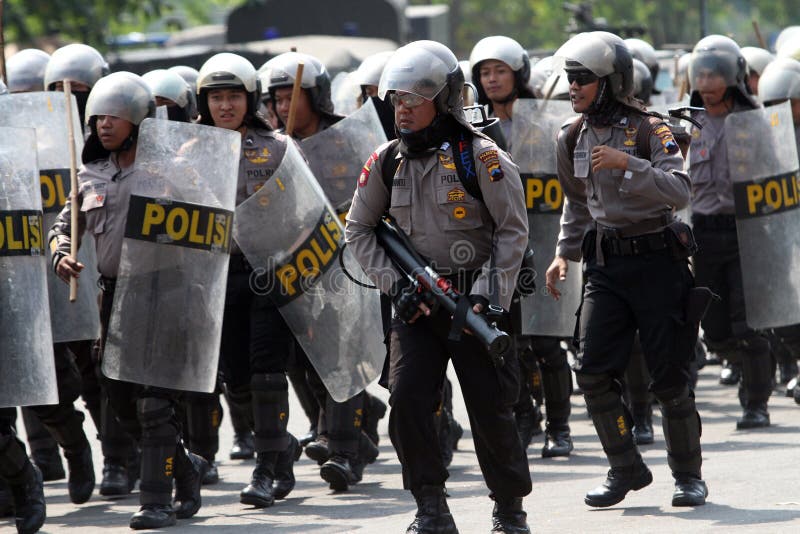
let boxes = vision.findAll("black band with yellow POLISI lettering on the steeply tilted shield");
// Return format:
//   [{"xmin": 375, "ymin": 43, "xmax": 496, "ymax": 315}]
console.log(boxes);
[{"xmin": 269, "ymin": 212, "xmax": 344, "ymax": 306}]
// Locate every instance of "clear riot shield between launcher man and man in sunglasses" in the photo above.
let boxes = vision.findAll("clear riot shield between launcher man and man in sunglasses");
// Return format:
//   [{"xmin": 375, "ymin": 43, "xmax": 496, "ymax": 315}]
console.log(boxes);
[{"xmin": 511, "ymin": 99, "xmax": 582, "ymax": 337}]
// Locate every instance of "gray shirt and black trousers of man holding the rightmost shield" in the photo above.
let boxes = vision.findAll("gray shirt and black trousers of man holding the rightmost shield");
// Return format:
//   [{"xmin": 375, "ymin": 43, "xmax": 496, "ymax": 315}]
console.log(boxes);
[{"xmin": 689, "ymin": 103, "xmax": 773, "ymax": 418}]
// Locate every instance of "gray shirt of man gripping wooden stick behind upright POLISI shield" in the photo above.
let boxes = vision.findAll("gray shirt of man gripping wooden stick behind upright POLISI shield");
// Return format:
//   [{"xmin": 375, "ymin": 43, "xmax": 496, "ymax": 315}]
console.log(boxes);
[{"xmin": 49, "ymin": 154, "xmax": 136, "ymax": 278}]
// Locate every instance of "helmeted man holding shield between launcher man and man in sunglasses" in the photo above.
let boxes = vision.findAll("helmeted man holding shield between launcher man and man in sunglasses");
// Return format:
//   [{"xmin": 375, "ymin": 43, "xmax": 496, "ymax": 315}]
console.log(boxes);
[{"xmin": 470, "ymin": 35, "xmax": 573, "ymax": 458}]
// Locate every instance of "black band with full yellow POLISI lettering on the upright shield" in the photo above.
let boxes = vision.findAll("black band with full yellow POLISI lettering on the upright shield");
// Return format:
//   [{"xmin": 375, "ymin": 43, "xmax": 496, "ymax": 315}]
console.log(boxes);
[{"xmin": 125, "ymin": 195, "xmax": 233, "ymax": 254}]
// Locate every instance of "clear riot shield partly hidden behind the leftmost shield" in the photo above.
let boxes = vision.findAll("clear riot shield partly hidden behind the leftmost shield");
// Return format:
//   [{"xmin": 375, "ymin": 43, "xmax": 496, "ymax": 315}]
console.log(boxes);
[{"xmin": 0, "ymin": 92, "xmax": 100, "ymax": 343}]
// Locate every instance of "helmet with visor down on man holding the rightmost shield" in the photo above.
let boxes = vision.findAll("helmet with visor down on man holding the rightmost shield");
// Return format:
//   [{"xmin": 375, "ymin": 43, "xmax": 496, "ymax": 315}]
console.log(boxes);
[{"xmin": 689, "ymin": 35, "xmax": 756, "ymax": 107}]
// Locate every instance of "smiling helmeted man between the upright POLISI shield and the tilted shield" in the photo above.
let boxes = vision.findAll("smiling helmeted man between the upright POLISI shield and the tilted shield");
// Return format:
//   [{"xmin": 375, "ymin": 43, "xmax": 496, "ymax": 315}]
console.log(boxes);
[{"xmin": 197, "ymin": 53, "xmax": 300, "ymax": 508}]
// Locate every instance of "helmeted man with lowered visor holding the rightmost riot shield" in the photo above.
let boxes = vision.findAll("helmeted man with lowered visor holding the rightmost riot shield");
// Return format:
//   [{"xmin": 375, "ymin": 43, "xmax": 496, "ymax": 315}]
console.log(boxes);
[{"xmin": 689, "ymin": 35, "xmax": 774, "ymax": 429}]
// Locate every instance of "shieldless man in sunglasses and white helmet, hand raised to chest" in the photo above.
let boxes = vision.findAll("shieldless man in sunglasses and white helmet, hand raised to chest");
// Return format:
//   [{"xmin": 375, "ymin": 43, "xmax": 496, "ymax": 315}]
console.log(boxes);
[{"xmin": 547, "ymin": 32, "xmax": 708, "ymax": 507}]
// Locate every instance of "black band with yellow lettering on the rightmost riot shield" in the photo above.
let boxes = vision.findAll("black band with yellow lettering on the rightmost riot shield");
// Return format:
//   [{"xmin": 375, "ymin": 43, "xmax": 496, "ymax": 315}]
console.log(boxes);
[{"xmin": 733, "ymin": 171, "xmax": 800, "ymax": 219}]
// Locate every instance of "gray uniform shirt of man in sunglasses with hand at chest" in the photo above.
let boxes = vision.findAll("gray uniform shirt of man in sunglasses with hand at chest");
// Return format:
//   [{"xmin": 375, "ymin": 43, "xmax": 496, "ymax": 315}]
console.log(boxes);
[{"xmin": 556, "ymin": 113, "xmax": 691, "ymax": 261}]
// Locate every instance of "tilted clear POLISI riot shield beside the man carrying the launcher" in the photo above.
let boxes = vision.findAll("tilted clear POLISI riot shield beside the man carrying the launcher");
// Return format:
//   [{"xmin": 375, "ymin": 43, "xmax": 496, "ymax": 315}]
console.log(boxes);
[{"xmin": 234, "ymin": 144, "xmax": 386, "ymax": 402}]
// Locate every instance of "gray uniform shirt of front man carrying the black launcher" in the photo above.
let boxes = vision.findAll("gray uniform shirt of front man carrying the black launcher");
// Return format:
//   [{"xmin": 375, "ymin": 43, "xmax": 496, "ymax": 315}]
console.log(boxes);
[{"xmin": 345, "ymin": 136, "xmax": 528, "ymax": 309}]
